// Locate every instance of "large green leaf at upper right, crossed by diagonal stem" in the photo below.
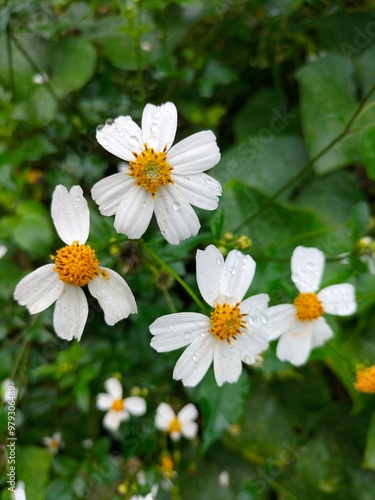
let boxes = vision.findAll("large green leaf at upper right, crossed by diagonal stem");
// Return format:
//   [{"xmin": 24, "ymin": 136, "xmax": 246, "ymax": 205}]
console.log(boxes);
[{"xmin": 297, "ymin": 54, "xmax": 358, "ymax": 173}]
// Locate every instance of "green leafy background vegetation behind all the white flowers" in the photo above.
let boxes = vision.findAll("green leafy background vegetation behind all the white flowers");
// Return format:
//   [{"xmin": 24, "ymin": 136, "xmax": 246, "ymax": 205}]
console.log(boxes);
[{"xmin": 0, "ymin": 0, "xmax": 375, "ymax": 500}]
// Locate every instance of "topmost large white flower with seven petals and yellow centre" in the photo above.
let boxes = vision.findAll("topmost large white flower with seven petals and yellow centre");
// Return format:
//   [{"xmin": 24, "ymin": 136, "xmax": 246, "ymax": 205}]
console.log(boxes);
[{"xmin": 91, "ymin": 102, "xmax": 221, "ymax": 245}]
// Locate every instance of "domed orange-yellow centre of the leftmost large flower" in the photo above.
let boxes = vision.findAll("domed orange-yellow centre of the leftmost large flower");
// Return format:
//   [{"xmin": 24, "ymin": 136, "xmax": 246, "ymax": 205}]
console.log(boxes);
[{"xmin": 51, "ymin": 241, "xmax": 101, "ymax": 286}]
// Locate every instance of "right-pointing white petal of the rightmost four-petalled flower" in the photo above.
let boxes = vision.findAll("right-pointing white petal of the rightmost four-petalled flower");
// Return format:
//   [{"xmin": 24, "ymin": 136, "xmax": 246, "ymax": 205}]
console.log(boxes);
[{"xmin": 318, "ymin": 283, "xmax": 357, "ymax": 316}]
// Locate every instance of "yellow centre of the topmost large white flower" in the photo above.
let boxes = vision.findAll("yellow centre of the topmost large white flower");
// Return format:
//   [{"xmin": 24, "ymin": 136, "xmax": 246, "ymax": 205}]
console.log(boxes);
[{"xmin": 129, "ymin": 144, "xmax": 174, "ymax": 198}]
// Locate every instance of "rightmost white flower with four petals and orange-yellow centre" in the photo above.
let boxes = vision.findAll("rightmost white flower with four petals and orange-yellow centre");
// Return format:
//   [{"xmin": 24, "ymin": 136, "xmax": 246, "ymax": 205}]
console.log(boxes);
[{"xmin": 268, "ymin": 246, "xmax": 357, "ymax": 366}]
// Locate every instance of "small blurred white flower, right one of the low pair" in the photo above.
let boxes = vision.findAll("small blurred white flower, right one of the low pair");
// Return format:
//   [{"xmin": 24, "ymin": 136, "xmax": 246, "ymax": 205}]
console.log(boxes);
[{"xmin": 155, "ymin": 403, "xmax": 198, "ymax": 441}]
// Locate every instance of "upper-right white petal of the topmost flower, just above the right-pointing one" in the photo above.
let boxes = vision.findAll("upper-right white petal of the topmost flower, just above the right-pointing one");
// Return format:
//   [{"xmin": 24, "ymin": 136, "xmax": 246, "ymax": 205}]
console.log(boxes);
[{"xmin": 167, "ymin": 130, "xmax": 220, "ymax": 175}]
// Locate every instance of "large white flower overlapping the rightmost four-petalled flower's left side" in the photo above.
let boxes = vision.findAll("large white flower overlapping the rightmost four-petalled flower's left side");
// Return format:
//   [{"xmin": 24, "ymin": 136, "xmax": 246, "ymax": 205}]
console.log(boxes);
[{"xmin": 150, "ymin": 245, "xmax": 269, "ymax": 386}]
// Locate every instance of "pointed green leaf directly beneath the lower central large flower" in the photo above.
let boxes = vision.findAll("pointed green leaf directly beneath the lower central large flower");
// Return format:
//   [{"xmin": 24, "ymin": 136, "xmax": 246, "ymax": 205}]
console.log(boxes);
[{"xmin": 191, "ymin": 370, "xmax": 249, "ymax": 453}]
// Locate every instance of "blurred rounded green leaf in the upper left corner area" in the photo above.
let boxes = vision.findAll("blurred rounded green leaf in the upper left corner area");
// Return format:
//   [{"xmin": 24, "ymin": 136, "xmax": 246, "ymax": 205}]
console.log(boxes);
[{"xmin": 49, "ymin": 38, "xmax": 96, "ymax": 97}]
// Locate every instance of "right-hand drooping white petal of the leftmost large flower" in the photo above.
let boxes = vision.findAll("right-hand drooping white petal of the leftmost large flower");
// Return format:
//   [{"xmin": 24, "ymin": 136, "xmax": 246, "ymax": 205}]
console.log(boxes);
[{"xmin": 88, "ymin": 267, "xmax": 137, "ymax": 325}]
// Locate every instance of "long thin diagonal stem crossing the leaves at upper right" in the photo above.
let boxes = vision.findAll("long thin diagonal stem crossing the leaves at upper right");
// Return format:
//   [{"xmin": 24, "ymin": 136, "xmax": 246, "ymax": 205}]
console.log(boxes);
[{"xmin": 233, "ymin": 83, "xmax": 375, "ymax": 233}]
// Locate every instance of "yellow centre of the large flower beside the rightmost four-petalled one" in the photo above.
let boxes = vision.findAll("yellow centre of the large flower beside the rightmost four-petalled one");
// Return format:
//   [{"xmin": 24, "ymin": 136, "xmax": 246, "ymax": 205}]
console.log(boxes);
[{"xmin": 209, "ymin": 302, "xmax": 248, "ymax": 345}]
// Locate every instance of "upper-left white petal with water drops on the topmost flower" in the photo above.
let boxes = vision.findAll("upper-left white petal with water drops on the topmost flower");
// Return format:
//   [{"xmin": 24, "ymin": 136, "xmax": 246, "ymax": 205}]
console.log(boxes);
[{"xmin": 96, "ymin": 116, "xmax": 144, "ymax": 161}]
